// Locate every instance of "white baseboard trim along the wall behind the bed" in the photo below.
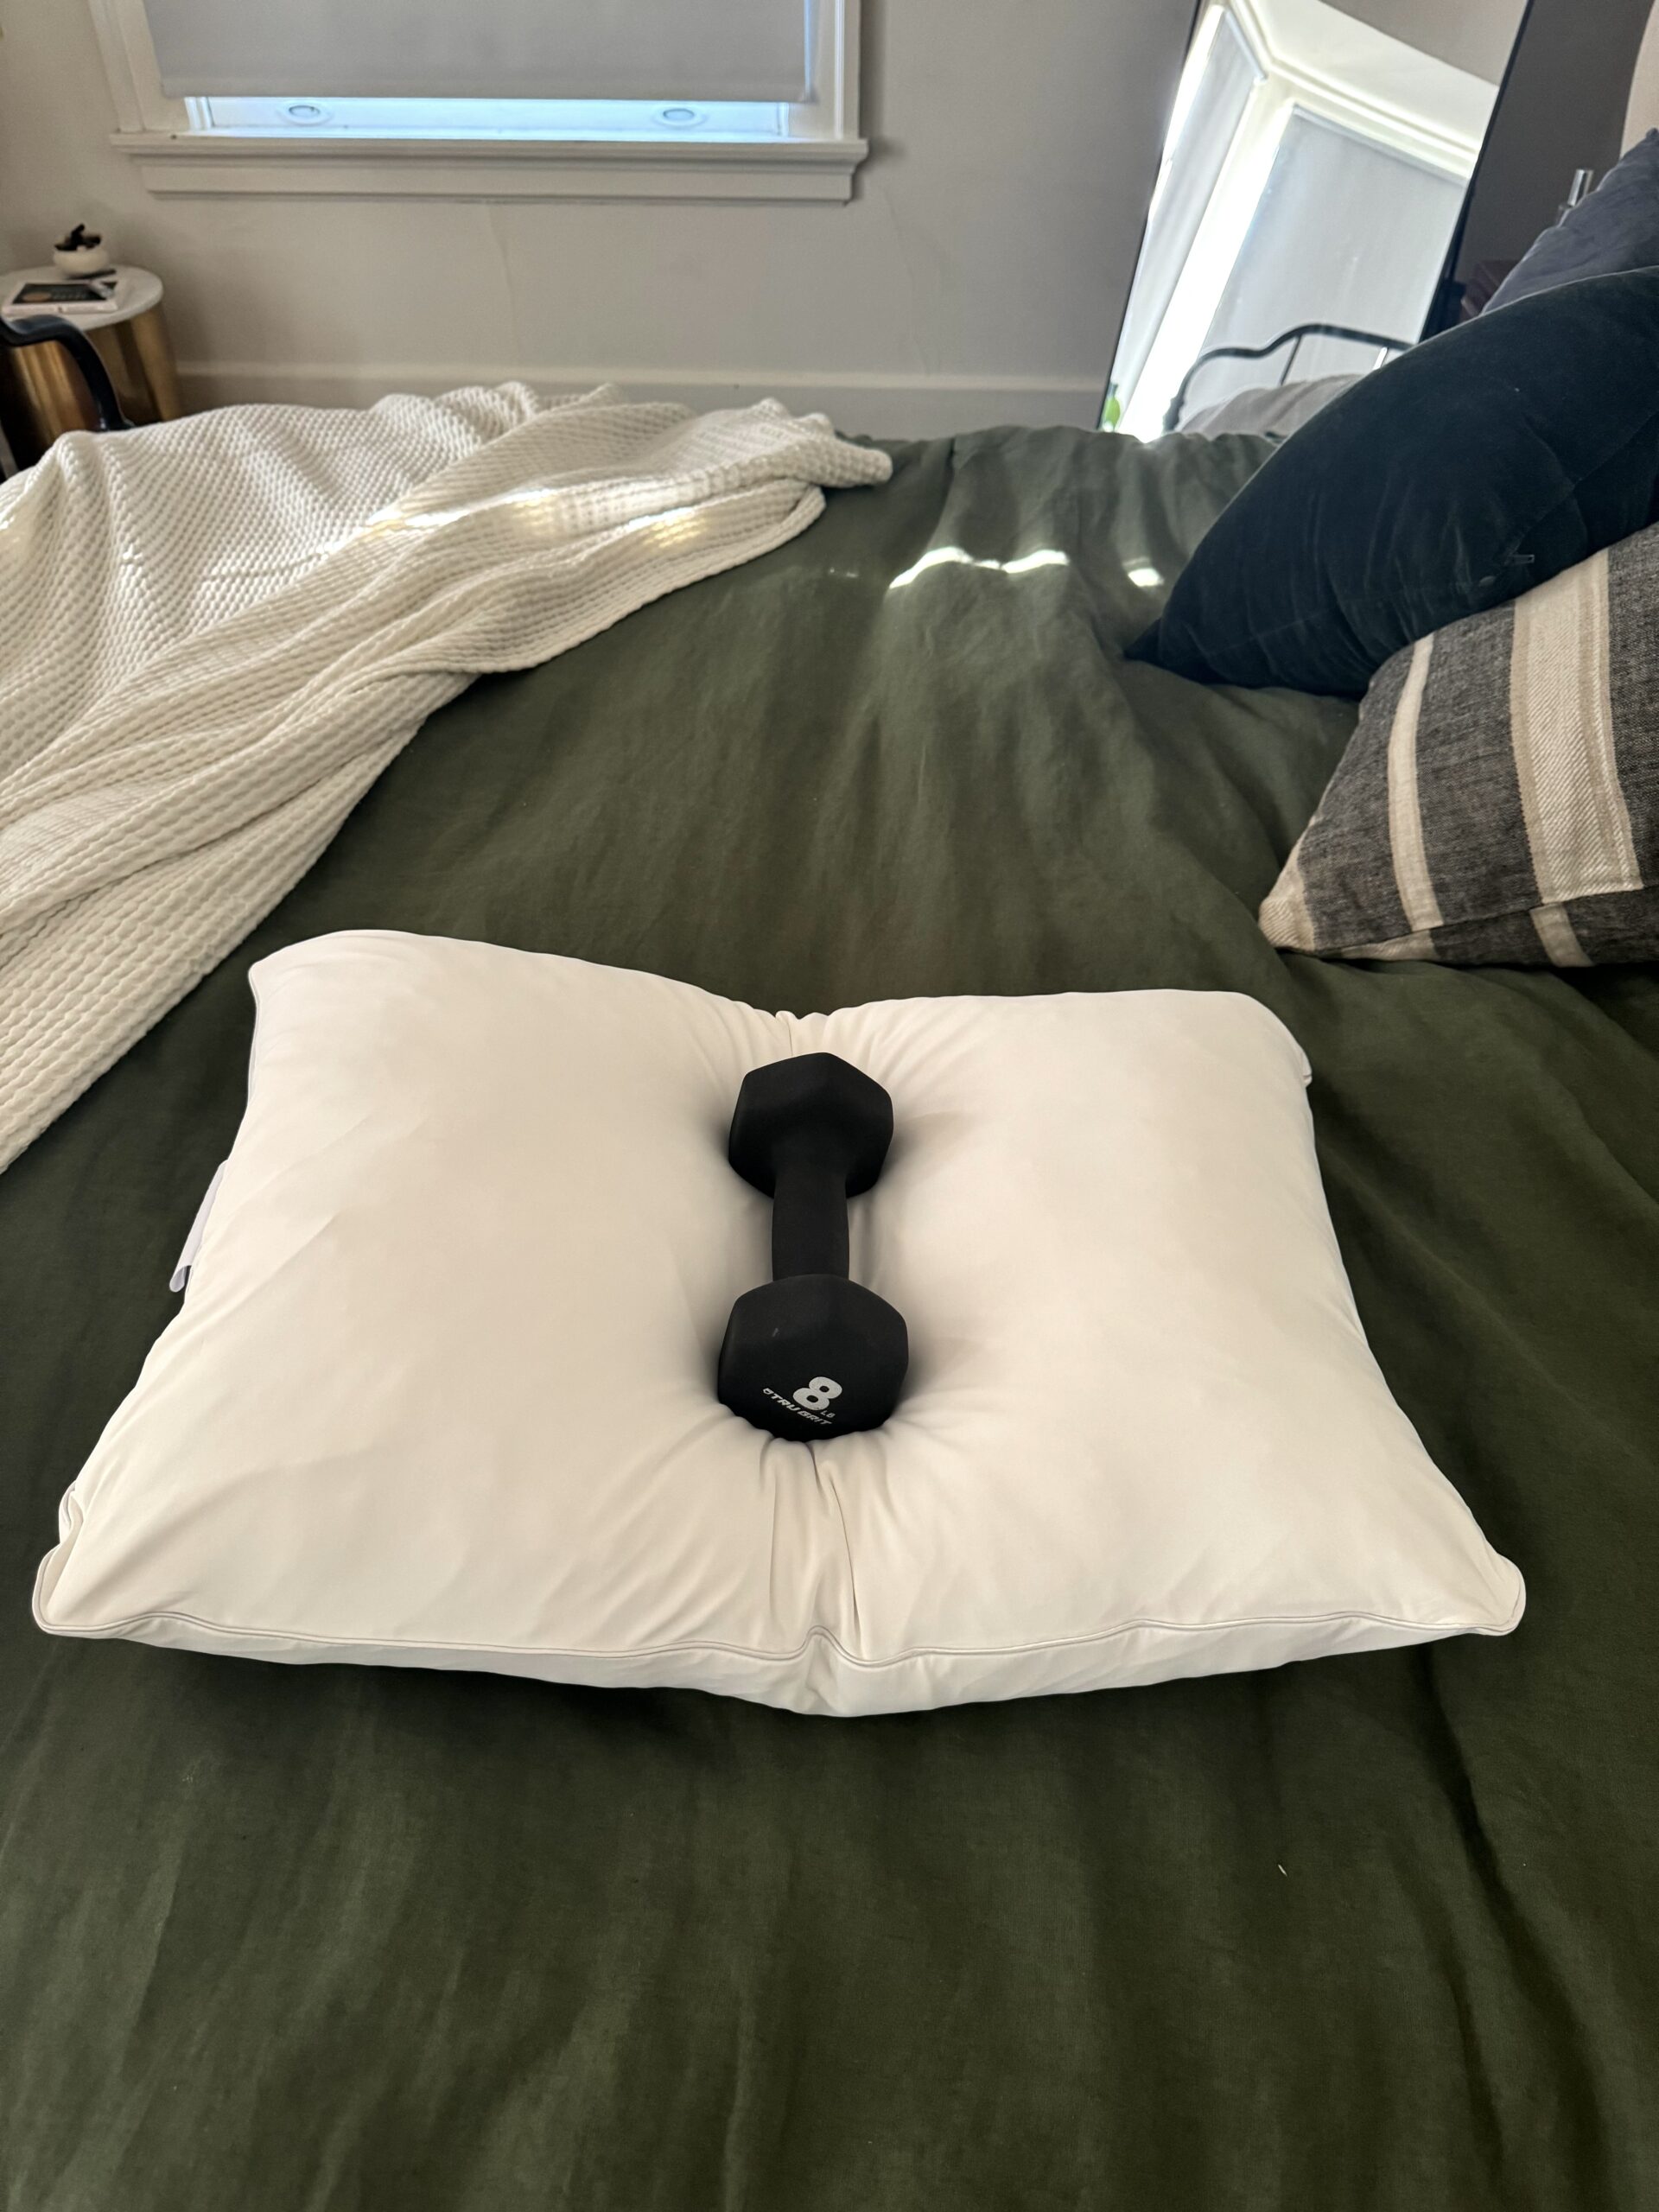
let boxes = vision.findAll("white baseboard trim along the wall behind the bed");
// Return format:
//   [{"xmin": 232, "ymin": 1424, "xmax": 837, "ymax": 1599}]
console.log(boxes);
[{"xmin": 179, "ymin": 360, "xmax": 1102, "ymax": 438}]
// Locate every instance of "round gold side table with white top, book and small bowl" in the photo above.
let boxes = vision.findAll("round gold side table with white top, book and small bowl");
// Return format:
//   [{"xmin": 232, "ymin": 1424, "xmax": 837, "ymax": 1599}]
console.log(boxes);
[{"xmin": 0, "ymin": 242, "xmax": 183, "ymax": 465}]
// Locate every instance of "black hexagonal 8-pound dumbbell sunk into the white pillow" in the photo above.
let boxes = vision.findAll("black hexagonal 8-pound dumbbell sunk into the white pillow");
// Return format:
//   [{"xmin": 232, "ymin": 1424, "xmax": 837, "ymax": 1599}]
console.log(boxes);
[{"xmin": 716, "ymin": 1053, "xmax": 909, "ymax": 1440}]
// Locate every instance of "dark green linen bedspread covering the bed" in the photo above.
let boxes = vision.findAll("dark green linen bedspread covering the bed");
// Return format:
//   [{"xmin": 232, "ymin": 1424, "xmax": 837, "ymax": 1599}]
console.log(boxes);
[{"xmin": 0, "ymin": 431, "xmax": 1659, "ymax": 2212}]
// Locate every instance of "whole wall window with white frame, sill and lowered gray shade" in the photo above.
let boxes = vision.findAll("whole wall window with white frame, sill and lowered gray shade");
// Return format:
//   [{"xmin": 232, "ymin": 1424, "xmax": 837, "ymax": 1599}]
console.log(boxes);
[{"xmin": 91, "ymin": 0, "xmax": 868, "ymax": 199}]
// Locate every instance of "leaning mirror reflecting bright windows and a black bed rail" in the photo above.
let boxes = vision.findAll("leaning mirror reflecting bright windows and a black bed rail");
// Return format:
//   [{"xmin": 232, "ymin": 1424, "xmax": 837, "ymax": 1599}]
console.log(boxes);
[{"xmin": 1102, "ymin": 0, "xmax": 1526, "ymax": 438}]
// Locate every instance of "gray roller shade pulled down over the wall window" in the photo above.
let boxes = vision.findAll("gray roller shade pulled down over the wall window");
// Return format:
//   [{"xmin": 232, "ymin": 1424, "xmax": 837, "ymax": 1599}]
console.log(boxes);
[{"xmin": 146, "ymin": 0, "xmax": 810, "ymax": 102}]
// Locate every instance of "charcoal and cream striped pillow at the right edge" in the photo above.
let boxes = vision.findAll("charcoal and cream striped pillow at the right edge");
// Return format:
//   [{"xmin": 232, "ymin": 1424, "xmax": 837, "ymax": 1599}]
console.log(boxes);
[{"xmin": 1261, "ymin": 524, "xmax": 1659, "ymax": 967}]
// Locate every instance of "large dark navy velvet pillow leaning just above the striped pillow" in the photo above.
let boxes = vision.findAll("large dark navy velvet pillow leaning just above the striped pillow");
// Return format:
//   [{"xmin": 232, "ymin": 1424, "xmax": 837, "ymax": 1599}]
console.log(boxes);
[{"xmin": 1130, "ymin": 270, "xmax": 1659, "ymax": 699}]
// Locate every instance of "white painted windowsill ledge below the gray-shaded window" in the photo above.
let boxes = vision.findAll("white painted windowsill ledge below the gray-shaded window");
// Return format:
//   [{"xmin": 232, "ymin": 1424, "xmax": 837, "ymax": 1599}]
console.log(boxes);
[{"xmin": 111, "ymin": 130, "xmax": 869, "ymax": 201}]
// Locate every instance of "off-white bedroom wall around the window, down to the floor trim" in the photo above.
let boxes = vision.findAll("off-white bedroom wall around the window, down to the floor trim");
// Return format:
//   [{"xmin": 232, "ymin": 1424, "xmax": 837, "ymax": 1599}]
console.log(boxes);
[{"xmin": 0, "ymin": 0, "xmax": 1192, "ymax": 435}]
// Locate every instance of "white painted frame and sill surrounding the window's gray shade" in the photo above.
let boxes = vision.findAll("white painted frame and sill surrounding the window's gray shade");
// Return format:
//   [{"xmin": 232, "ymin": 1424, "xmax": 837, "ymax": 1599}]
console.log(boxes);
[{"xmin": 88, "ymin": 0, "xmax": 869, "ymax": 201}]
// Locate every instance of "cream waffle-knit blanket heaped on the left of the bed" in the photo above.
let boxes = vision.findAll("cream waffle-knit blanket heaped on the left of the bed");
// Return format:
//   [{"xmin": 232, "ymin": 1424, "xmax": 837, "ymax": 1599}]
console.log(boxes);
[{"xmin": 0, "ymin": 385, "xmax": 889, "ymax": 1168}]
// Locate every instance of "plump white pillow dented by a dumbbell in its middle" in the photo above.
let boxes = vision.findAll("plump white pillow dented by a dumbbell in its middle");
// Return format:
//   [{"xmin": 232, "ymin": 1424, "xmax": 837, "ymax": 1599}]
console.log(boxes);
[{"xmin": 35, "ymin": 931, "xmax": 1522, "ymax": 1714}]
